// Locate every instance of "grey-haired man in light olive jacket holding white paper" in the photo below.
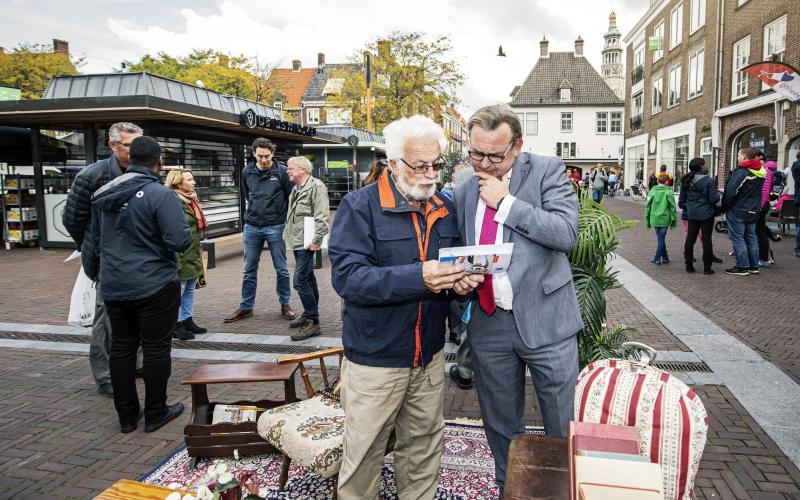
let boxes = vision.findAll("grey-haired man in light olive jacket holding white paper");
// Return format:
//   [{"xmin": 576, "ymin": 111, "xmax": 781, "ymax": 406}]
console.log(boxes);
[{"xmin": 283, "ymin": 156, "xmax": 330, "ymax": 340}]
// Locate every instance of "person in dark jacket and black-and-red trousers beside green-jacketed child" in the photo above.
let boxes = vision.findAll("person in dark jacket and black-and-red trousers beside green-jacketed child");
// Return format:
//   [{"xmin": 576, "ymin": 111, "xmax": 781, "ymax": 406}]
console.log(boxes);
[{"xmin": 678, "ymin": 158, "xmax": 721, "ymax": 274}]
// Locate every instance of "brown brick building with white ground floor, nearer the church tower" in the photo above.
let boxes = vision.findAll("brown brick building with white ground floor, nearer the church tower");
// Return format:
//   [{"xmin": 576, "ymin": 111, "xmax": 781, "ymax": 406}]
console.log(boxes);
[{"xmin": 624, "ymin": 0, "xmax": 716, "ymax": 187}]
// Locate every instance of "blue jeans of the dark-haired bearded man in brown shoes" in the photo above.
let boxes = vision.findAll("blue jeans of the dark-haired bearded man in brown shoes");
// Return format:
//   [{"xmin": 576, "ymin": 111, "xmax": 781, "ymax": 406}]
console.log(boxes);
[{"xmin": 239, "ymin": 224, "xmax": 292, "ymax": 310}]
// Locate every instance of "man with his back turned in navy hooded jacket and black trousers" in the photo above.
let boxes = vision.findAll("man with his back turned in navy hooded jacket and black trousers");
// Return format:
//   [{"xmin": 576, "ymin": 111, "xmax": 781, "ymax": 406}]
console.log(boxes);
[{"xmin": 86, "ymin": 137, "xmax": 192, "ymax": 433}]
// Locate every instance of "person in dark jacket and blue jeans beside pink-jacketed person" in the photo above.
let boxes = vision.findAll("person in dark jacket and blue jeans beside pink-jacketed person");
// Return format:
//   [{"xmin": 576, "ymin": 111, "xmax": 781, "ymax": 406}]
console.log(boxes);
[{"xmin": 722, "ymin": 148, "xmax": 766, "ymax": 276}]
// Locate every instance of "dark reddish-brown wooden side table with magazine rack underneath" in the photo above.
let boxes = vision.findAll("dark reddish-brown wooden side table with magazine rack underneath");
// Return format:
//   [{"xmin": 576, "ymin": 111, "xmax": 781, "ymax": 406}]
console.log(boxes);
[{"xmin": 181, "ymin": 363, "xmax": 298, "ymax": 466}]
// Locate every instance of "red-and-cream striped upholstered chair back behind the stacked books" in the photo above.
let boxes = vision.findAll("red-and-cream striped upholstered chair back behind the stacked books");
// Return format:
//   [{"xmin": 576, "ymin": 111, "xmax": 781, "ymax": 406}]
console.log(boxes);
[{"xmin": 575, "ymin": 359, "xmax": 708, "ymax": 499}]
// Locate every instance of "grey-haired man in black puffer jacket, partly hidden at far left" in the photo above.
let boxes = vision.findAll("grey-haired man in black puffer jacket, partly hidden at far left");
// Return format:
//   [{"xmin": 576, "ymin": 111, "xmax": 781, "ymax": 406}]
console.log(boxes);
[{"xmin": 61, "ymin": 122, "xmax": 142, "ymax": 397}]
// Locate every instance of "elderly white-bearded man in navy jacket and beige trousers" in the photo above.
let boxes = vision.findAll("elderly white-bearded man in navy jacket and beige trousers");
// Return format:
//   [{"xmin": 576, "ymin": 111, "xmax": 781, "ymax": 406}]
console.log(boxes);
[{"xmin": 329, "ymin": 116, "xmax": 483, "ymax": 500}]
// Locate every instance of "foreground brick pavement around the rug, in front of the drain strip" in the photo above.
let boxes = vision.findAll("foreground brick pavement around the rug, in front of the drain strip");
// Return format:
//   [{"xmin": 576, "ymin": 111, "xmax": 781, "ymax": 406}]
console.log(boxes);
[{"xmin": 0, "ymin": 349, "xmax": 800, "ymax": 499}]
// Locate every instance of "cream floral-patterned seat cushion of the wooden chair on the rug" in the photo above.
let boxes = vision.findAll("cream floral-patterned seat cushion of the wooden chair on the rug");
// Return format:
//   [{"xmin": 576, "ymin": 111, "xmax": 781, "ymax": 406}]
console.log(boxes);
[{"xmin": 258, "ymin": 395, "xmax": 344, "ymax": 478}]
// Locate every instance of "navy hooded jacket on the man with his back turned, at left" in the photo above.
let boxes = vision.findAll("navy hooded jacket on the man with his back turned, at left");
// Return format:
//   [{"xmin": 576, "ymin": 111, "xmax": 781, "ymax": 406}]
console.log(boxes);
[{"xmin": 86, "ymin": 165, "xmax": 192, "ymax": 301}]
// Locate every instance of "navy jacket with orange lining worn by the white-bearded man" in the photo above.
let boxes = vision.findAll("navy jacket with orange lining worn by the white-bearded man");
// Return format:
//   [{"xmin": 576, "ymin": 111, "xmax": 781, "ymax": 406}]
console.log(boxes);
[{"xmin": 328, "ymin": 171, "xmax": 460, "ymax": 368}]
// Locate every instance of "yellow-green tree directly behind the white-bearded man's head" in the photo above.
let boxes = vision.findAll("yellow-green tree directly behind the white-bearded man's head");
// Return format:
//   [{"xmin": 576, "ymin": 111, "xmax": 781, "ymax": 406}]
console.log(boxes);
[{"xmin": 328, "ymin": 32, "xmax": 464, "ymax": 133}]
